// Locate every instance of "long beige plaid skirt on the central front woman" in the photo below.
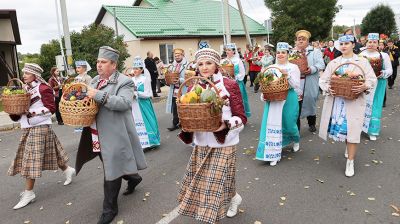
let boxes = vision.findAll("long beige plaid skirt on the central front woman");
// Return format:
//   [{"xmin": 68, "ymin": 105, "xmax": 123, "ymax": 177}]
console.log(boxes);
[{"xmin": 178, "ymin": 146, "xmax": 236, "ymax": 223}]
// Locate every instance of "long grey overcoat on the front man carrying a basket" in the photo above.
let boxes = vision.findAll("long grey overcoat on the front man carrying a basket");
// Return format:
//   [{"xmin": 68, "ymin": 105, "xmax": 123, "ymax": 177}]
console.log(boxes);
[{"xmin": 76, "ymin": 72, "xmax": 147, "ymax": 181}]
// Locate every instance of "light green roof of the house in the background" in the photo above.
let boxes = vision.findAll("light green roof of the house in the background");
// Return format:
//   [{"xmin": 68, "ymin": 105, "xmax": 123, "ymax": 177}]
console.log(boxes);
[{"xmin": 96, "ymin": 0, "xmax": 267, "ymax": 38}]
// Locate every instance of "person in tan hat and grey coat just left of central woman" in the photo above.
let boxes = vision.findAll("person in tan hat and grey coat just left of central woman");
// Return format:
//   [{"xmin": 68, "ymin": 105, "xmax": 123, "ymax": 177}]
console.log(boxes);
[{"xmin": 166, "ymin": 48, "xmax": 188, "ymax": 131}]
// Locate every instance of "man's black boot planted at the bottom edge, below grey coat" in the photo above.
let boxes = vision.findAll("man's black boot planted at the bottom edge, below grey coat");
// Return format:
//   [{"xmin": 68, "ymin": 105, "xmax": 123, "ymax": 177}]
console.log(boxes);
[{"xmin": 97, "ymin": 177, "xmax": 122, "ymax": 224}]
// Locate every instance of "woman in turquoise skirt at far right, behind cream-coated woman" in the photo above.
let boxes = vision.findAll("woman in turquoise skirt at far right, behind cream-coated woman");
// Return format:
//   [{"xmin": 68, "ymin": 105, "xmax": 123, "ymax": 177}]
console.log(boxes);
[{"xmin": 360, "ymin": 33, "xmax": 393, "ymax": 141}]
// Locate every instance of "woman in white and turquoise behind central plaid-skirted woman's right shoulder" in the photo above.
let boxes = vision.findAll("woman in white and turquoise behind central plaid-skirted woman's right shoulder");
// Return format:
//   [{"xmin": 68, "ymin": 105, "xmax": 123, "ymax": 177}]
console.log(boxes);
[{"xmin": 225, "ymin": 43, "xmax": 251, "ymax": 117}]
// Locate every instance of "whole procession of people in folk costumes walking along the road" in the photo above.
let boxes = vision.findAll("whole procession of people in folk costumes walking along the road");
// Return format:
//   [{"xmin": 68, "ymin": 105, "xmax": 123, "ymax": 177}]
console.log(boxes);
[{"xmin": 8, "ymin": 26, "xmax": 400, "ymax": 224}]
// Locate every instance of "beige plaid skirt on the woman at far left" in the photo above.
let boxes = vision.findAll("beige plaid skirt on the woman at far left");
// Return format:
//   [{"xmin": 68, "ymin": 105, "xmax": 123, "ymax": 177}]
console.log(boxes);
[{"xmin": 8, "ymin": 125, "xmax": 68, "ymax": 179}]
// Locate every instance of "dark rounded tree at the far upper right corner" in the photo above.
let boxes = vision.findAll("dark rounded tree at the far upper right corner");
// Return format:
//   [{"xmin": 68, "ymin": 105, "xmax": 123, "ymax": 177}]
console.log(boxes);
[{"xmin": 361, "ymin": 4, "xmax": 396, "ymax": 36}]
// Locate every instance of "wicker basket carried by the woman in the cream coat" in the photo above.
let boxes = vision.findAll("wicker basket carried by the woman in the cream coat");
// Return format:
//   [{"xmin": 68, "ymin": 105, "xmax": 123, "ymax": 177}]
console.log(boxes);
[{"xmin": 330, "ymin": 62, "xmax": 365, "ymax": 100}]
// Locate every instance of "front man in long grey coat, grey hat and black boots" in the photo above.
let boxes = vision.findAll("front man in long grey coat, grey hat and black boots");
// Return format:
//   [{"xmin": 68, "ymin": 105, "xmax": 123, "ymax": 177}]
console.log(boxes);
[{"xmin": 76, "ymin": 46, "xmax": 147, "ymax": 224}]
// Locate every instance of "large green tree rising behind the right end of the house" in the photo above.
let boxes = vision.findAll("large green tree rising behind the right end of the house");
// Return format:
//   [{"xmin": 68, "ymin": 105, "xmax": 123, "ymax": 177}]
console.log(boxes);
[{"xmin": 265, "ymin": 0, "xmax": 341, "ymax": 44}]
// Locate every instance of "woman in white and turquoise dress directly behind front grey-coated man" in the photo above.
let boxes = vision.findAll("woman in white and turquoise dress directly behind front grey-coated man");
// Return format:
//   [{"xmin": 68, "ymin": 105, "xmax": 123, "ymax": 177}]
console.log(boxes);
[{"xmin": 132, "ymin": 57, "xmax": 160, "ymax": 149}]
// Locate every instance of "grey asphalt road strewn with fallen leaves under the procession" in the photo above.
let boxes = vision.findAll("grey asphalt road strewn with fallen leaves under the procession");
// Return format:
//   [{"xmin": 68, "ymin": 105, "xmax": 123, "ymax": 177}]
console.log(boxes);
[{"xmin": 0, "ymin": 81, "xmax": 400, "ymax": 224}]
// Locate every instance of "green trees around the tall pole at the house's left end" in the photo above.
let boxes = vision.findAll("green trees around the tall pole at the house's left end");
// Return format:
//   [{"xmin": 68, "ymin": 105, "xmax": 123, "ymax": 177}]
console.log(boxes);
[{"xmin": 39, "ymin": 23, "xmax": 130, "ymax": 78}]
